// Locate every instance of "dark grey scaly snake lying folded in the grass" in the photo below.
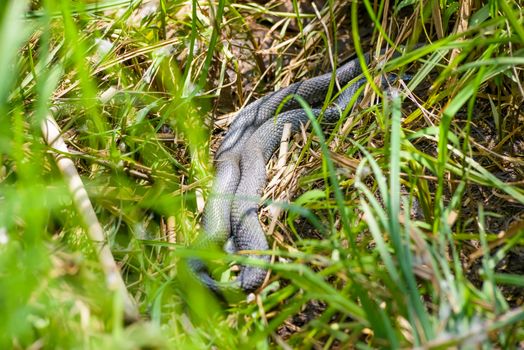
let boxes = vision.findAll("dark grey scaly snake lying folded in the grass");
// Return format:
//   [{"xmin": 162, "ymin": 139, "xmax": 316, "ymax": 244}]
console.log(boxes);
[{"xmin": 188, "ymin": 50, "xmax": 384, "ymax": 294}]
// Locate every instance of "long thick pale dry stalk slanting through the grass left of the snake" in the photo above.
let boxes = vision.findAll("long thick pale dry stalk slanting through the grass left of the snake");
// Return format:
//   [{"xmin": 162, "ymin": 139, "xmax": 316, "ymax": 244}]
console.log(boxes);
[{"xmin": 41, "ymin": 112, "xmax": 139, "ymax": 322}]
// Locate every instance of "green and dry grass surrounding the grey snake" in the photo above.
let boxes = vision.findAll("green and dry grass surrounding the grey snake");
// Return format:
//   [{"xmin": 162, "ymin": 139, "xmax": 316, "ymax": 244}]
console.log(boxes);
[{"xmin": 0, "ymin": 0, "xmax": 524, "ymax": 349}]
